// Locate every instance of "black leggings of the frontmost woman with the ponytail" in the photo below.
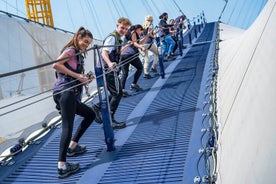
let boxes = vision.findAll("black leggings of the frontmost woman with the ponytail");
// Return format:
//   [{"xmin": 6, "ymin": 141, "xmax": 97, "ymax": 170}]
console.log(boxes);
[{"xmin": 54, "ymin": 91, "xmax": 95, "ymax": 162}]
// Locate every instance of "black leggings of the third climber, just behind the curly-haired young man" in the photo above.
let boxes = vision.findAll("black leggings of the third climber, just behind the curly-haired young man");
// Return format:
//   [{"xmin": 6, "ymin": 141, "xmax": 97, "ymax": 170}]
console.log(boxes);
[{"xmin": 121, "ymin": 55, "xmax": 143, "ymax": 89}]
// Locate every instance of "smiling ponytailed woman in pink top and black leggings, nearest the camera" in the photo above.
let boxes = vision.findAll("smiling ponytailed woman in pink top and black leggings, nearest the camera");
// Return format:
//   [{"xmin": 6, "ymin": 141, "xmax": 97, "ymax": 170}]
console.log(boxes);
[{"xmin": 53, "ymin": 27, "xmax": 95, "ymax": 178}]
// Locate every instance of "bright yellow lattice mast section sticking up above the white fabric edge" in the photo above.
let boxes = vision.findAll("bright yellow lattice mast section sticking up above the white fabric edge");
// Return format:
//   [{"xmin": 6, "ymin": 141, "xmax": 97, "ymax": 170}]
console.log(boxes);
[{"xmin": 25, "ymin": 0, "xmax": 54, "ymax": 27}]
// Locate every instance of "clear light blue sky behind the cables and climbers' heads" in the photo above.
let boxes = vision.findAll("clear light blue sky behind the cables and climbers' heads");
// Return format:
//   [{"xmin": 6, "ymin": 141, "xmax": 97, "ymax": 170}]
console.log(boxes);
[{"xmin": 0, "ymin": 0, "xmax": 267, "ymax": 40}]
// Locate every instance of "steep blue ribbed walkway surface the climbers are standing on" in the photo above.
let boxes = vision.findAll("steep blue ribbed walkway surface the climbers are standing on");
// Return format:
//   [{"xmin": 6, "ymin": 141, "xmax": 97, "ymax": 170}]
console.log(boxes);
[{"xmin": 0, "ymin": 23, "xmax": 216, "ymax": 184}]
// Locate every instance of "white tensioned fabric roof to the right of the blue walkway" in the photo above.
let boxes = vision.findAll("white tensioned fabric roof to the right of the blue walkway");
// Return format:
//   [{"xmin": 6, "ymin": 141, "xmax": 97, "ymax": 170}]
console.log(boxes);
[{"xmin": 218, "ymin": 0, "xmax": 276, "ymax": 184}]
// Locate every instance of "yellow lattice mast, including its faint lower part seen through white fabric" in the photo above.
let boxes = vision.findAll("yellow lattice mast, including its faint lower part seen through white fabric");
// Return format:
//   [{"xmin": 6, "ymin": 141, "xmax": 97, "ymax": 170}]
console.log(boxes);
[{"xmin": 25, "ymin": 0, "xmax": 57, "ymax": 91}]
